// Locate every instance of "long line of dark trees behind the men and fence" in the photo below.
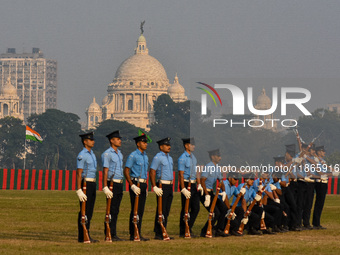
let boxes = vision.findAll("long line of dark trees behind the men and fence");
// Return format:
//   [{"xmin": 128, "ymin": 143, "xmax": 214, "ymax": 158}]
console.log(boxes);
[{"xmin": 0, "ymin": 95, "xmax": 340, "ymax": 170}]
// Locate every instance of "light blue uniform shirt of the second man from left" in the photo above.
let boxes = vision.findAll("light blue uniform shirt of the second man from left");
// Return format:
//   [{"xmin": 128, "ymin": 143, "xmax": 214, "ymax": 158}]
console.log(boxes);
[{"xmin": 102, "ymin": 147, "xmax": 124, "ymax": 180}]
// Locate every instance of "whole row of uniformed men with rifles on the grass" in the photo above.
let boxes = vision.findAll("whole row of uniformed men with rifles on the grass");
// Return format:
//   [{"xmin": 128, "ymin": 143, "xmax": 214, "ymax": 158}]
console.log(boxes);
[{"xmin": 76, "ymin": 130, "xmax": 331, "ymax": 243}]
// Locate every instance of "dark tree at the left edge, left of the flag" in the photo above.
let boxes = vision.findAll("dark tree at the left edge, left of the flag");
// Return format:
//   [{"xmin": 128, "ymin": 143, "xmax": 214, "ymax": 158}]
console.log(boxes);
[{"xmin": 0, "ymin": 117, "xmax": 25, "ymax": 169}]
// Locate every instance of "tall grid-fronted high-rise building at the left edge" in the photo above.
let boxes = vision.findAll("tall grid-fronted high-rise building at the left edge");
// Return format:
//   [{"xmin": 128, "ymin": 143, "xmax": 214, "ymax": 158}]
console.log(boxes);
[{"xmin": 0, "ymin": 48, "xmax": 57, "ymax": 120}]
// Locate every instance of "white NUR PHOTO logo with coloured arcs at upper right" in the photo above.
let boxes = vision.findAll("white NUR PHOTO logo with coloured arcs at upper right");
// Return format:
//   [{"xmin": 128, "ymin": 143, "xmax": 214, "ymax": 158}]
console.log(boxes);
[{"xmin": 197, "ymin": 82, "xmax": 312, "ymax": 128}]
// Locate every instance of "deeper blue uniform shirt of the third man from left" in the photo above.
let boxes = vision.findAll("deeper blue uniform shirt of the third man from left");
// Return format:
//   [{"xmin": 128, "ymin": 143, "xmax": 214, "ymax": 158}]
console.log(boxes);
[{"xmin": 125, "ymin": 149, "xmax": 149, "ymax": 179}]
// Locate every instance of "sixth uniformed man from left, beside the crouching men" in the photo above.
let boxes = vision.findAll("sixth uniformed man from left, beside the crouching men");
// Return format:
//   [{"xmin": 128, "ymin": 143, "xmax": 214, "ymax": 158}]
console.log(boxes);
[{"xmin": 201, "ymin": 149, "xmax": 228, "ymax": 237}]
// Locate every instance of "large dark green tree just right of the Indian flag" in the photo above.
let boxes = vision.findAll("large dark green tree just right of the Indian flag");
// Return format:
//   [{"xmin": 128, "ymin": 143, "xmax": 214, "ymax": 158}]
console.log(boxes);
[{"xmin": 27, "ymin": 109, "xmax": 82, "ymax": 169}]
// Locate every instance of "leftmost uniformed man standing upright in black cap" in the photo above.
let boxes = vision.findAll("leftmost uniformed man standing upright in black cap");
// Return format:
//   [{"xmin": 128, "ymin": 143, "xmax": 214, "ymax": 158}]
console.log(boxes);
[{"xmin": 77, "ymin": 132, "xmax": 98, "ymax": 243}]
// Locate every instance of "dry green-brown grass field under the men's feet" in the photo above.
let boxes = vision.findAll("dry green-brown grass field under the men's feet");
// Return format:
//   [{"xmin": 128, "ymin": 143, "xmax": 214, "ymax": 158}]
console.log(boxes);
[{"xmin": 0, "ymin": 190, "xmax": 340, "ymax": 255}]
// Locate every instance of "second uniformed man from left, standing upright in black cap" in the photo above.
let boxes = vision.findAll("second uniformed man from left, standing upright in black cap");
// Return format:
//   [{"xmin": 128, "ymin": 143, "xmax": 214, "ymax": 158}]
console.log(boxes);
[{"xmin": 102, "ymin": 130, "xmax": 124, "ymax": 241}]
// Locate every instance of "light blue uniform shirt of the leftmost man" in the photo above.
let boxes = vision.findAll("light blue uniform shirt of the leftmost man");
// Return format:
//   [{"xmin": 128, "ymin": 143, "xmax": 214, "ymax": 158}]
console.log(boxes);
[{"xmin": 77, "ymin": 148, "xmax": 97, "ymax": 178}]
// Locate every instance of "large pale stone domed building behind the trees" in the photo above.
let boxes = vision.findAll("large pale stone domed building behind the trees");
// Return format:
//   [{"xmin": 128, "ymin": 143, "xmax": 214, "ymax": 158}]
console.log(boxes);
[{"xmin": 86, "ymin": 33, "xmax": 187, "ymax": 130}]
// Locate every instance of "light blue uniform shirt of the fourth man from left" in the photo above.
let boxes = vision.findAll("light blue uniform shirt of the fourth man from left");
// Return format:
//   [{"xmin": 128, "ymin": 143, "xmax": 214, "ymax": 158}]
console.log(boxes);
[{"xmin": 150, "ymin": 151, "xmax": 174, "ymax": 181}]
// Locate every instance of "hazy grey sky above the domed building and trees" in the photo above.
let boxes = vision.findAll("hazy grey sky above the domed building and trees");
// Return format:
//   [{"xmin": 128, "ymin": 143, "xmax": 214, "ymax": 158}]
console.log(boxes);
[{"xmin": 0, "ymin": 0, "xmax": 340, "ymax": 121}]
